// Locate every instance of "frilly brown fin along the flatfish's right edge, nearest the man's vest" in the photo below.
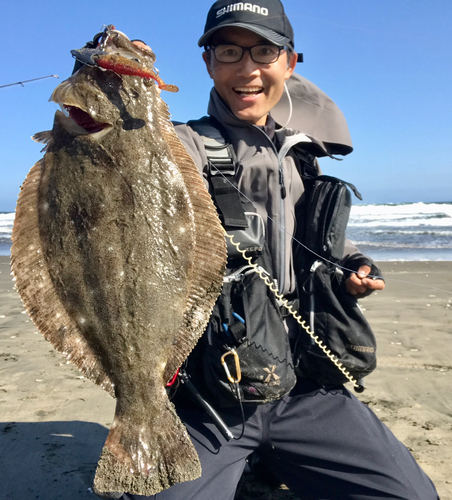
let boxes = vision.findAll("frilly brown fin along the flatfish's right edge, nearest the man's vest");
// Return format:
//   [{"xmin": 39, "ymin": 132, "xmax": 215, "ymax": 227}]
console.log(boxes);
[{"xmin": 155, "ymin": 96, "xmax": 227, "ymax": 380}]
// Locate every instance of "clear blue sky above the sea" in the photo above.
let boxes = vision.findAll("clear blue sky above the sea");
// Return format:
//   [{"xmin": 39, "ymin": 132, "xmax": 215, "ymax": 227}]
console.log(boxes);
[{"xmin": 0, "ymin": 0, "xmax": 452, "ymax": 211}]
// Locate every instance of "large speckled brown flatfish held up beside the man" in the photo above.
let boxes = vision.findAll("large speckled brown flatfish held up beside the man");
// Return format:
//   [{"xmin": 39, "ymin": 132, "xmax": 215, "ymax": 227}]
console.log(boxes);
[{"xmin": 11, "ymin": 27, "xmax": 226, "ymax": 495}]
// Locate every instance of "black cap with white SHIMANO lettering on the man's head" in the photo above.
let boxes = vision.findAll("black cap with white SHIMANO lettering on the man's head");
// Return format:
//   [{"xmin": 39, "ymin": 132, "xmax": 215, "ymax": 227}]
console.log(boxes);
[{"xmin": 198, "ymin": 0, "xmax": 294, "ymax": 49}]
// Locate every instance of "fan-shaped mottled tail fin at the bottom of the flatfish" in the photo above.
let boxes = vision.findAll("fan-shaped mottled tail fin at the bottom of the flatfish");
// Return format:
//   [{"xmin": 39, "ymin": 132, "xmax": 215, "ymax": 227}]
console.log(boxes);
[{"xmin": 94, "ymin": 401, "xmax": 201, "ymax": 496}]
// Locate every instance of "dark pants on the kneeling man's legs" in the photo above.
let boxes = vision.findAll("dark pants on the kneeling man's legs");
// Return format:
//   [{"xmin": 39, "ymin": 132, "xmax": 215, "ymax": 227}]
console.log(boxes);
[{"xmin": 121, "ymin": 381, "xmax": 439, "ymax": 500}]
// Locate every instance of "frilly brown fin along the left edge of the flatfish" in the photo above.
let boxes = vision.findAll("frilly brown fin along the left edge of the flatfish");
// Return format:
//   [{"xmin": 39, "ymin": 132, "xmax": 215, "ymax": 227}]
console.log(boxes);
[{"xmin": 11, "ymin": 159, "xmax": 114, "ymax": 396}]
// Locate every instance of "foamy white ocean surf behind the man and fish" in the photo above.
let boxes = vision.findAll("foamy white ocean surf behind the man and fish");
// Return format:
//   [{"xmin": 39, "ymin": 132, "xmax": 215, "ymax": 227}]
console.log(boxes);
[{"xmin": 0, "ymin": 202, "xmax": 452, "ymax": 262}]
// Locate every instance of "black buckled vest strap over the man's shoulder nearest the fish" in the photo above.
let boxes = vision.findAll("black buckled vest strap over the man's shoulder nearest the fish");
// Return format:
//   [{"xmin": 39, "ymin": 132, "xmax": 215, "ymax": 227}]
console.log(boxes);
[{"xmin": 187, "ymin": 116, "xmax": 248, "ymax": 229}]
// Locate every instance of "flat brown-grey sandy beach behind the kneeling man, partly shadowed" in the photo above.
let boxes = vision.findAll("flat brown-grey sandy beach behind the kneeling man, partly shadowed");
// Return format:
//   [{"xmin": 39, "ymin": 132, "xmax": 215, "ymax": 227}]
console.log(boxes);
[{"xmin": 0, "ymin": 257, "xmax": 452, "ymax": 500}]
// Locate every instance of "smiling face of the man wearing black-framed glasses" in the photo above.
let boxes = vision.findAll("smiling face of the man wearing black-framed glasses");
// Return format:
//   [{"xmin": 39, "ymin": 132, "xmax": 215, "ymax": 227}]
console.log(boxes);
[{"xmin": 203, "ymin": 27, "xmax": 297, "ymax": 125}]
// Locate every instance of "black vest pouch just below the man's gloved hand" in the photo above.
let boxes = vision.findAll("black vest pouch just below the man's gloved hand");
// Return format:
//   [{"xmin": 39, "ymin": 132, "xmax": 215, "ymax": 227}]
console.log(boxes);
[{"xmin": 294, "ymin": 260, "xmax": 377, "ymax": 391}]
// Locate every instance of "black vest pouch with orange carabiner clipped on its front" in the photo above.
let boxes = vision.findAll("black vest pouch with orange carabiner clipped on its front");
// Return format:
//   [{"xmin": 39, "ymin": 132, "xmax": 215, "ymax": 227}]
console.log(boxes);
[{"xmin": 202, "ymin": 267, "xmax": 296, "ymax": 406}]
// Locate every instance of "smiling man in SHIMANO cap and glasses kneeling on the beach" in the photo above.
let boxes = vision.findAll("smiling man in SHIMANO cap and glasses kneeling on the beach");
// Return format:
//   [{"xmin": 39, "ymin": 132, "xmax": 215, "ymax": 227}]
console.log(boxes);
[{"xmin": 115, "ymin": 0, "xmax": 438, "ymax": 500}]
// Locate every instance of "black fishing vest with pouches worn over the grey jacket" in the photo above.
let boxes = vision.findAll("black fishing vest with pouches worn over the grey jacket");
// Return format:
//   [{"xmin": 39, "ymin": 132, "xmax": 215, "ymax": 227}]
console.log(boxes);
[{"xmin": 184, "ymin": 117, "xmax": 375, "ymax": 406}]
